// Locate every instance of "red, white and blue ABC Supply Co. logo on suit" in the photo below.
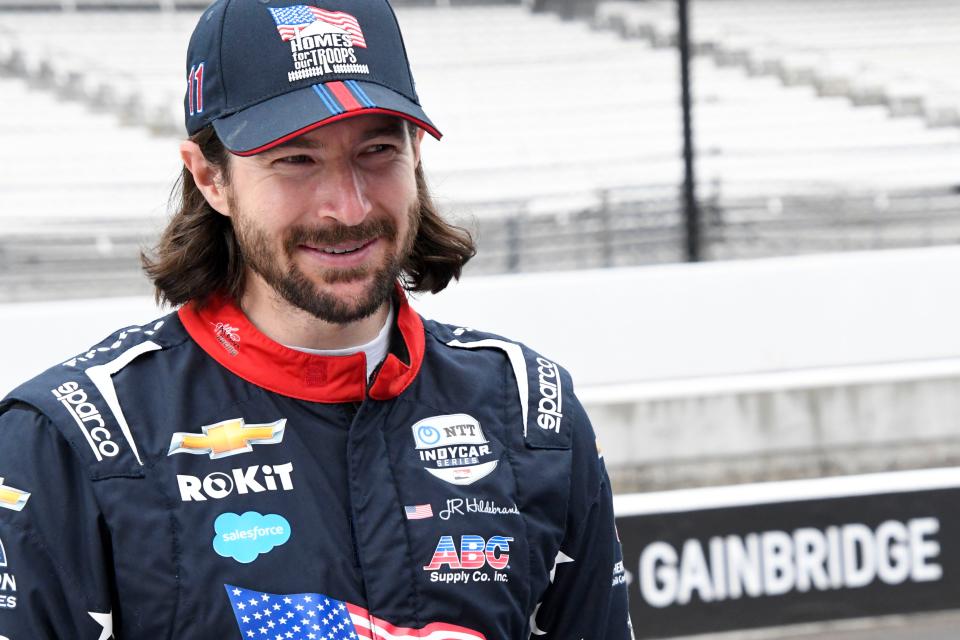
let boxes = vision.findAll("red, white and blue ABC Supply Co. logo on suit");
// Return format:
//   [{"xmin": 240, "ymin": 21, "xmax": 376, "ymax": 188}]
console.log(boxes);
[{"xmin": 423, "ymin": 535, "xmax": 513, "ymax": 584}]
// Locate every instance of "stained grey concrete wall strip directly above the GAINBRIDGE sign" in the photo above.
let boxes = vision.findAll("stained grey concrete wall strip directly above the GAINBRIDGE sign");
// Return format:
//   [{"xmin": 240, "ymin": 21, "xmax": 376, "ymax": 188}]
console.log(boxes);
[{"xmin": 586, "ymin": 360, "xmax": 960, "ymax": 492}]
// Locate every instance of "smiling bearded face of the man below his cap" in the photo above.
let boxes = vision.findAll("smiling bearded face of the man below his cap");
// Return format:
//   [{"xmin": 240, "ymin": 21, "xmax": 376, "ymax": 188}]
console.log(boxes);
[{"xmin": 227, "ymin": 115, "xmax": 420, "ymax": 324}]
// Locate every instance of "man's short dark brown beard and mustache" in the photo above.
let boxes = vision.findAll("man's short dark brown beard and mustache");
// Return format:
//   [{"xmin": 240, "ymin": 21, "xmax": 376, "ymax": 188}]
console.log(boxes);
[{"xmin": 233, "ymin": 204, "xmax": 420, "ymax": 325}]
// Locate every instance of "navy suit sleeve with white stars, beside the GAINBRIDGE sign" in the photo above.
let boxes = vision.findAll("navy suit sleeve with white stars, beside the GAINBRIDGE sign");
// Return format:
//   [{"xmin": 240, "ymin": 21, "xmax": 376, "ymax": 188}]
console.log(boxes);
[{"xmin": 530, "ymin": 405, "xmax": 633, "ymax": 640}]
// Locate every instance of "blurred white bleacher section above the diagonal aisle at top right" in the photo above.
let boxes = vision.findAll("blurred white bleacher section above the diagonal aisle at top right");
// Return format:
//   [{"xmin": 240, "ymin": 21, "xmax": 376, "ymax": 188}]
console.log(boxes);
[{"xmin": 596, "ymin": 0, "xmax": 960, "ymax": 126}]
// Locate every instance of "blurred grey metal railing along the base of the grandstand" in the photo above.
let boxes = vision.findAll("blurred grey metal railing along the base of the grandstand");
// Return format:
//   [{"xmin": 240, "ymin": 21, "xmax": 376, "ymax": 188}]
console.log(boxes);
[{"xmin": 0, "ymin": 188, "xmax": 960, "ymax": 301}]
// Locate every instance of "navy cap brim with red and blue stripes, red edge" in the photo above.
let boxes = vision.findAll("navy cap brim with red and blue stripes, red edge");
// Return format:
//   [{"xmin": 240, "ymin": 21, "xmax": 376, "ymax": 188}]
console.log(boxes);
[{"xmin": 213, "ymin": 80, "xmax": 442, "ymax": 156}]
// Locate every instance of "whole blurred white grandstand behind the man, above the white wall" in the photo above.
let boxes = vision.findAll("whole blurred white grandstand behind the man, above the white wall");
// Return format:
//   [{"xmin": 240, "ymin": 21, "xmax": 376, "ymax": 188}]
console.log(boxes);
[{"xmin": 0, "ymin": 0, "xmax": 960, "ymax": 299}]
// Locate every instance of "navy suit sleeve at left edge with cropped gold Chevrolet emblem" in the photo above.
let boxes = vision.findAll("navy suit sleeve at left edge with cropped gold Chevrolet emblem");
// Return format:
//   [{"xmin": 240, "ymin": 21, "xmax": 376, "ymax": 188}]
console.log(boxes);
[{"xmin": 0, "ymin": 403, "xmax": 112, "ymax": 640}]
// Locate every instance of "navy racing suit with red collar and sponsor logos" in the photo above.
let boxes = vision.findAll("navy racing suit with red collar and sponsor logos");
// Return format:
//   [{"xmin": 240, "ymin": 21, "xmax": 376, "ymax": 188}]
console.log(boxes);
[{"xmin": 0, "ymin": 294, "xmax": 631, "ymax": 640}]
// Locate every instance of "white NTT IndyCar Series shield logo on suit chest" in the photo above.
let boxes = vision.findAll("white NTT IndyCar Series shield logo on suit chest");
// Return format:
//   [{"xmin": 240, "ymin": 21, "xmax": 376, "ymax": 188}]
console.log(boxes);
[{"xmin": 413, "ymin": 413, "xmax": 498, "ymax": 485}]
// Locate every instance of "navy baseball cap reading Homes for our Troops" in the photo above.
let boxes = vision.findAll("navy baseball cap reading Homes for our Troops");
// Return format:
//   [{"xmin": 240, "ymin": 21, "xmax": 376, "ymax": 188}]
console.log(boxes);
[{"xmin": 184, "ymin": 0, "xmax": 441, "ymax": 156}]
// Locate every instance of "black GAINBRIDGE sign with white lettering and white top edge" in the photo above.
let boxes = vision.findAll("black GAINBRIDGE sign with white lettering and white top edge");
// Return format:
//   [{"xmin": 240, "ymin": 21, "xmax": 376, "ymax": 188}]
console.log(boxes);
[{"xmin": 615, "ymin": 469, "xmax": 960, "ymax": 638}]
